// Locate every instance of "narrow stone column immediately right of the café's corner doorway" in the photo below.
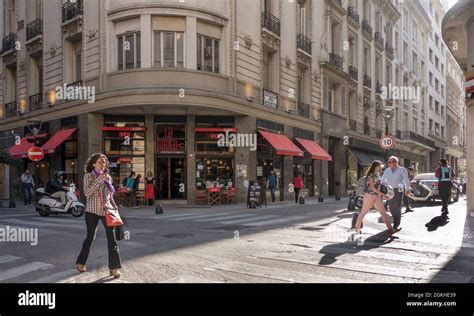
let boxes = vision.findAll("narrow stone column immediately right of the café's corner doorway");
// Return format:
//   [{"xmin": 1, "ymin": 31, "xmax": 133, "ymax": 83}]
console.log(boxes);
[{"xmin": 186, "ymin": 115, "xmax": 196, "ymax": 204}]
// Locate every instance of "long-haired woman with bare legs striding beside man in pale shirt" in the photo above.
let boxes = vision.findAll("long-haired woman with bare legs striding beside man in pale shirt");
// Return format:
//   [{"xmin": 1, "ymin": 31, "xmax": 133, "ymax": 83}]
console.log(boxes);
[{"xmin": 355, "ymin": 160, "xmax": 400, "ymax": 234}]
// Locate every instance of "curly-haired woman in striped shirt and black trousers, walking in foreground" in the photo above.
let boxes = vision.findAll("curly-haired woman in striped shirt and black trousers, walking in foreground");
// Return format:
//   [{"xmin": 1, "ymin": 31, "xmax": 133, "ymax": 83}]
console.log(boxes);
[{"xmin": 76, "ymin": 153, "xmax": 122, "ymax": 279}]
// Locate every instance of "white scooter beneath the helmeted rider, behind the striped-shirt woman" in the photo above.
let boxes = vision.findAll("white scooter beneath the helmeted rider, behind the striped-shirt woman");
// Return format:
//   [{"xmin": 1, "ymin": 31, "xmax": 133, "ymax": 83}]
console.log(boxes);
[{"xmin": 36, "ymin": 183, "xmax": 85, "ymax": 217}]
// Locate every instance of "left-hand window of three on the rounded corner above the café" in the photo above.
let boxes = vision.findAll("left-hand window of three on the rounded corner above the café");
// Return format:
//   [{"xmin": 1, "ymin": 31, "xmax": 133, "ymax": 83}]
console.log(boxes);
[{"xmin": 117, "ymin": 32, "xmax": 141, "ymax": 70}]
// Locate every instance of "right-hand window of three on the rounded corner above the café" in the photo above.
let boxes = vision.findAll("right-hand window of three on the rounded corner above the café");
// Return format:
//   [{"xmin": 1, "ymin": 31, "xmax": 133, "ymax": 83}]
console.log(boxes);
[{"xmin": 197, "ymin": 35, "xmax": 219, "ymax": 73}]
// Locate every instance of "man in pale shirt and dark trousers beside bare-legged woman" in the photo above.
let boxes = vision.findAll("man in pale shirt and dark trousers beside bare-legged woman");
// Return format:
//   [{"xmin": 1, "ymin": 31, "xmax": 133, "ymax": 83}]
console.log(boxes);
[{"xmin": 382, "ymin": 156, "xmax": 410, "ymax": 230}]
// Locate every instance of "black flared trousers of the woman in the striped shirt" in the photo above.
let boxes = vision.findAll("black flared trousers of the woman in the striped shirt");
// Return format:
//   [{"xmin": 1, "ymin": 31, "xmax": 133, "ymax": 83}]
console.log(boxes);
[{"xmin": 76, "ymin": 212, "xmax": 121, "ymax": 270}]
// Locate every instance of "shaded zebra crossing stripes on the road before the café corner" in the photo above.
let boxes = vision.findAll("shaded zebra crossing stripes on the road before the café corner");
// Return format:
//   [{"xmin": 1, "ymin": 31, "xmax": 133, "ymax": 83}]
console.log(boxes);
[{"xmin": 155, "ymin": 212, "xmax": 304, "ymax": 227}]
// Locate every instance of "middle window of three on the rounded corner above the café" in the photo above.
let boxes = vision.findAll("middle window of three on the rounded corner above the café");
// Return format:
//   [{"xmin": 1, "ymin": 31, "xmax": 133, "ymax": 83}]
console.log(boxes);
[{"xmin": 154, "ymin": 32, "xmax": 184, "ymax": 68}]
